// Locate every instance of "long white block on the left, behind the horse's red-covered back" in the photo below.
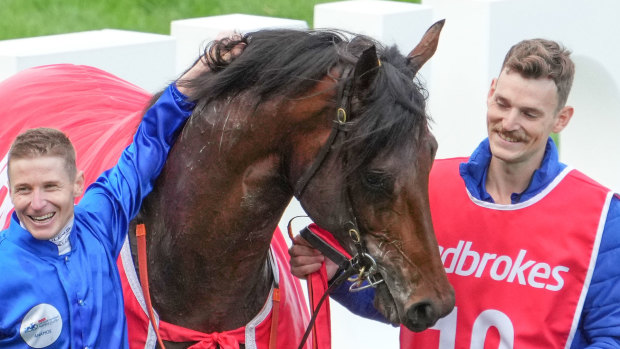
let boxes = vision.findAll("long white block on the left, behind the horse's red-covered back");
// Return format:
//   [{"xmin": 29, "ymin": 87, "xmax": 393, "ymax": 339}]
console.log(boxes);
[{"xmin": 0, "ymin": 29, "xmax": 176, "ymax": 92}]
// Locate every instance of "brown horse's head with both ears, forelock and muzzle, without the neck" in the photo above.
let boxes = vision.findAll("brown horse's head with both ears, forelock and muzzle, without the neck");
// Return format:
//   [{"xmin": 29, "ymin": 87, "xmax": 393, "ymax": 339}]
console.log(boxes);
[{"xmin": 296, "ymin": 21, "xmax": 454, "ymax": 331}]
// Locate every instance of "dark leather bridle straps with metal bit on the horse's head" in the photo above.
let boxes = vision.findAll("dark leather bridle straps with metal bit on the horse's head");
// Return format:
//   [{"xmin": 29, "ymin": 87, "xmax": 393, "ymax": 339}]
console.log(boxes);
[{"xmin": 295, "ymin": 66, "xmax": 383, "ymax": 292}]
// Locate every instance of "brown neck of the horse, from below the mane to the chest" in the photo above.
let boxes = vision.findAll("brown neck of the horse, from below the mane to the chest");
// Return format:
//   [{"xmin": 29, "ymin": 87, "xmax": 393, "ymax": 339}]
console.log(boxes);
[{"xmin": 145, "ymin": 76, "xmax": 335, "ymax": 332}]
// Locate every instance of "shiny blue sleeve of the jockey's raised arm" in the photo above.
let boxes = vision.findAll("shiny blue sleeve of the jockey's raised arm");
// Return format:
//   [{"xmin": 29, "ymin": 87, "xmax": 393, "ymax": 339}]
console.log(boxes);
[{"xmin": 78, "ymin": 84, "xmax": 193, "ymax": 255}]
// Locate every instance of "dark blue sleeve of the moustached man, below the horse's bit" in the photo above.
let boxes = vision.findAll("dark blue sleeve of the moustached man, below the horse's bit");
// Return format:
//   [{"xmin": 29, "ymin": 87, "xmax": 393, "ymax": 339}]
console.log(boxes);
[{"xmin": 330, "ymin": 274, "xmax": 391, "ymax": 324}]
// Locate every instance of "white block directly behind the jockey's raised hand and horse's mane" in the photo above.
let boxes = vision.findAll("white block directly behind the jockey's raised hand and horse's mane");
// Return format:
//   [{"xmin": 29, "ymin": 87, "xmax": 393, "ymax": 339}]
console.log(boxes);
[{"xmin": 170, "ymin": 14, "xmax": 308, "ymax": 73}]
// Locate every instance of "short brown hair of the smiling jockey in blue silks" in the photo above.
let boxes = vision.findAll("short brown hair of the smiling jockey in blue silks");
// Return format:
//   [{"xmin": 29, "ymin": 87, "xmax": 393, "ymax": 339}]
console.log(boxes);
[{"xmin": 7, "ymin": 127, "xmax": 77, "ymax": 181}]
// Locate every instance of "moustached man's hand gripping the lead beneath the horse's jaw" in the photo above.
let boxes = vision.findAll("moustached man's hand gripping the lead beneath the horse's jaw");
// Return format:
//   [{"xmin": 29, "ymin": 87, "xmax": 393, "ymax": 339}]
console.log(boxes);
[{"xmin": 288, "ymin": 235, "xmax": 338, "ymax": 280}]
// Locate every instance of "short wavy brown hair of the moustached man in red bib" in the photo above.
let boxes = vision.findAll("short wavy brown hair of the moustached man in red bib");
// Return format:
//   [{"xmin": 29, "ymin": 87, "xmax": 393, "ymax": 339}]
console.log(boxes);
[{"xmin": 502, "ymin": 39, "xmax": 575, "ymax": 110}]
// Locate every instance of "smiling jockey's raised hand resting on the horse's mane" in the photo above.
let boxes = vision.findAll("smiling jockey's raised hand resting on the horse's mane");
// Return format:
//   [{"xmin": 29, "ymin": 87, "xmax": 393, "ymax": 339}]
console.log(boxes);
[{"xmin": 177, "ymin": 31, "xmax": 245, "ymax": 96}]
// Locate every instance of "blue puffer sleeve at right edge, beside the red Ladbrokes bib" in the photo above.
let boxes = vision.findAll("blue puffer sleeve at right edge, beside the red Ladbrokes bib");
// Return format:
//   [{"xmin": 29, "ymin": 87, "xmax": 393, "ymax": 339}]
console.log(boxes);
[{"xmin": 571, "ymin": 194, "xmax": 620, "ymax": 348}]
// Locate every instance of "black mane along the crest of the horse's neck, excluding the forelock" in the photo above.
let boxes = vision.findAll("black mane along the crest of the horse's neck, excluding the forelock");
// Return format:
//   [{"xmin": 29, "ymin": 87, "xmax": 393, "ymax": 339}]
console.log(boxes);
[{"xmin": 185, "ymin": 29, "xmax": 346, "ymax": 101}]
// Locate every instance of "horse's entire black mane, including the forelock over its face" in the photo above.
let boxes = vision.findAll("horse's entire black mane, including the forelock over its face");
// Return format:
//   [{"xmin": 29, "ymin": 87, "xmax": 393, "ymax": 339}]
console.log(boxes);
[{"xmin": 188, "ymin": 29, "xmax": 427, "ymax": 172}]
